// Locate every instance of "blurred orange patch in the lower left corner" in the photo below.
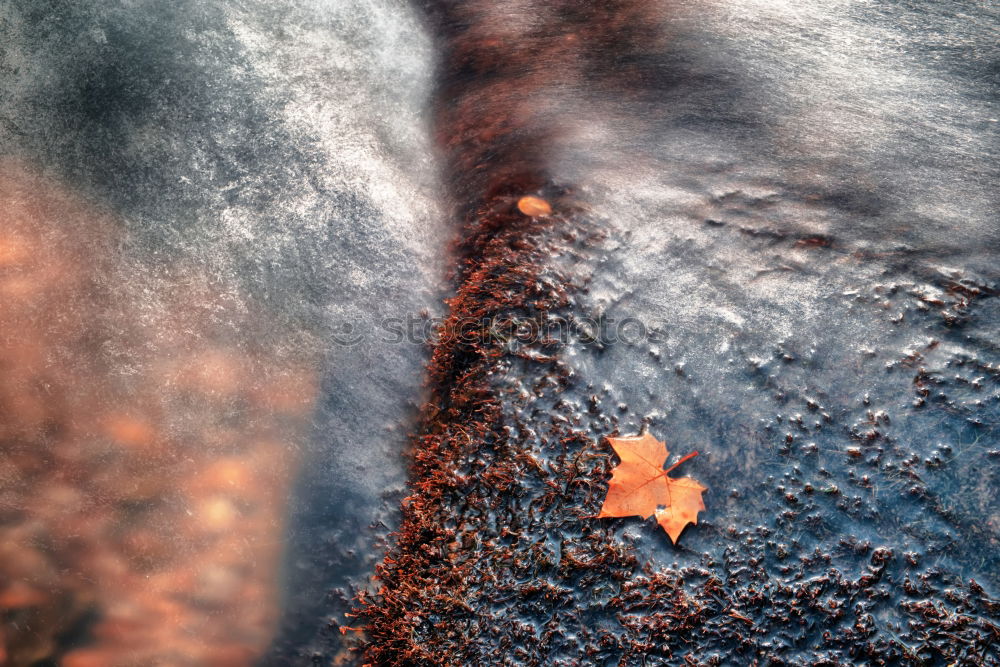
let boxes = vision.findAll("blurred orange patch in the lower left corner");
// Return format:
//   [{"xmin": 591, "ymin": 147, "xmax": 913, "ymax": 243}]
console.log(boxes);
[{"xmin": 0, "ymin": 163, "xmax": 316, "ymax": 667}]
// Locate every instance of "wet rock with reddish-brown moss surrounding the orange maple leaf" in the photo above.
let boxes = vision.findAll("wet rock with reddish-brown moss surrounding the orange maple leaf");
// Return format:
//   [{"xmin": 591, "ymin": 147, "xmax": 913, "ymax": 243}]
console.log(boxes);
[{"xmin": 359, "ymin": 2, "xmax": 1000, "ymax": 665}]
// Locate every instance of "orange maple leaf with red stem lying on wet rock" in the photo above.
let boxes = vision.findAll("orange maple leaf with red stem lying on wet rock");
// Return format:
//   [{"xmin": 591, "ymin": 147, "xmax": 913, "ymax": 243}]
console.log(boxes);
[{"xmin": 597, "ymin": 433, "xmax": 706, "ymax": 544}]
